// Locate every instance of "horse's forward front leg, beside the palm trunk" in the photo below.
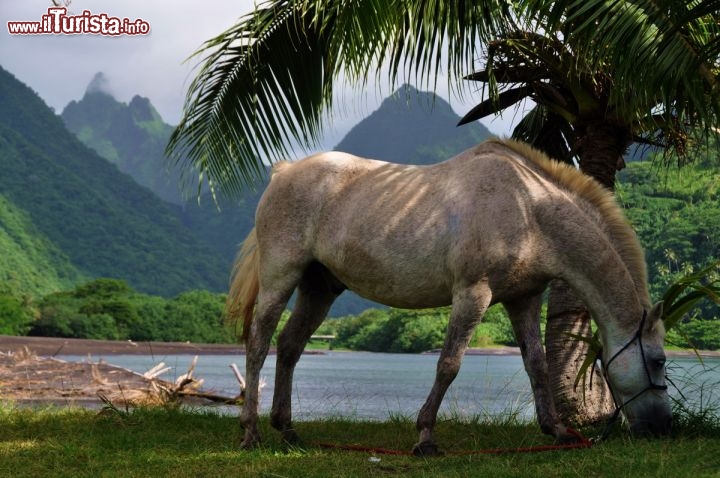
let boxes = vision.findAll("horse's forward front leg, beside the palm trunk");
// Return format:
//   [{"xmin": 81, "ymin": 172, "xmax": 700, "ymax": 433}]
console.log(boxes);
[{"xmin": 503, "ymin": 294, "xmax": 578, "ymax": 443}]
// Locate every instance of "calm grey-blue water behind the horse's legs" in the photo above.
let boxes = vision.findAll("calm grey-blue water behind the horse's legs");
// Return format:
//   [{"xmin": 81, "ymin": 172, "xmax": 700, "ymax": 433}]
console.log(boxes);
[{"xmin": 59, "ymin": 352, "xmax": 720, "ymax": 420}]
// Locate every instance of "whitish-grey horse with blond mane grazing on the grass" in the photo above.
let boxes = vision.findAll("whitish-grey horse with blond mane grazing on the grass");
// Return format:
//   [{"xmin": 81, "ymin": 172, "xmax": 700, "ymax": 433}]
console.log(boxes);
[{"xmin": 227, "ymin": 140, "xmax": 671, "ymax": 454}]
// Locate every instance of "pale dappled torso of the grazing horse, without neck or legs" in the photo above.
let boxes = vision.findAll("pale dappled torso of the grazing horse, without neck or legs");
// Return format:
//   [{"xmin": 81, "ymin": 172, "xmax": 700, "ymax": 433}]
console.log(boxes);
[{"xmin": 256, "ymin": 143, "xmax": 580, "ymax": 307}]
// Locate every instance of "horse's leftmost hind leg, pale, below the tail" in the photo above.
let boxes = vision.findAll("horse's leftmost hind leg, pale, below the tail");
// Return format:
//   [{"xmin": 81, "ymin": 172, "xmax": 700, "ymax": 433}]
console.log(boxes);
[{"xmin": 240, "ymin": 291, "xmax": 289, "ymax": 449}]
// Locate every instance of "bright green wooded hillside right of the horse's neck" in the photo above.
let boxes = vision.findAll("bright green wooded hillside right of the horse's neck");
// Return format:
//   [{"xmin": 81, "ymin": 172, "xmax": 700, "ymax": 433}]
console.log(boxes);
[{"xmin": 617, "ymin": 151, "xmax": 720, "ymax": 312}]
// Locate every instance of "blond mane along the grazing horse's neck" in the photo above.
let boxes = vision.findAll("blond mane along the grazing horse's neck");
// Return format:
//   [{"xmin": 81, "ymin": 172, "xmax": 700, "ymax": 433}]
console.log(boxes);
[{"xmin": 489, "ymin": 139, "xmax": 651, "ymax": 309}]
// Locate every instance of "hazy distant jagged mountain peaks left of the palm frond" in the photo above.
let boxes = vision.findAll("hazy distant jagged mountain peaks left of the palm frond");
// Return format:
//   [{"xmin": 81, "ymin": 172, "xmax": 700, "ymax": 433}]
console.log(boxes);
[{"xmin": 61, "ymin": 73, "xmax": 183, "ymax": 204}]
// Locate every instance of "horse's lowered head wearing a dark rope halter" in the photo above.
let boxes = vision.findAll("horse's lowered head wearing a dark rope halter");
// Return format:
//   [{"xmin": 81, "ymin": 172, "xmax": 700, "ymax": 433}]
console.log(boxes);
[{"xmin": 602, "ymin": 302, "xmax": 672, "ymax": 435}]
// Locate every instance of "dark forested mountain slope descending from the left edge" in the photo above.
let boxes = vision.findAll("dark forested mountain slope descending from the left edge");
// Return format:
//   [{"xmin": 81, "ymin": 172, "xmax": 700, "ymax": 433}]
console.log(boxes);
[{"xmin": 0, "ymin": 68, "xmax": 227, "ymax": 296}]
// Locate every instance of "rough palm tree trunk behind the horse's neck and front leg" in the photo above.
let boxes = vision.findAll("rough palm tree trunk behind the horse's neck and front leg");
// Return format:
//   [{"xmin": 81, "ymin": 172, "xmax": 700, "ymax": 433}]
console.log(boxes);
[{"xmin": 545, "ymin": 119, "xmax": 631, "ymax": 426}]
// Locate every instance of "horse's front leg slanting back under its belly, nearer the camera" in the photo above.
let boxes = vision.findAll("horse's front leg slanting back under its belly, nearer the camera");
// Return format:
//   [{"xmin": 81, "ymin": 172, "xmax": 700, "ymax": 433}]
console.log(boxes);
[{"xmin": 412, "ymin": 282, "xmax": 492, "ymax": 456}]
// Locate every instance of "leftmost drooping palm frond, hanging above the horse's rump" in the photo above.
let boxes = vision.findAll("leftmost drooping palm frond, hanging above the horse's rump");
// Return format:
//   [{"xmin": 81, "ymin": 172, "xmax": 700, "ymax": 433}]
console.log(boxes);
[{"xmin": 167, "ymin": 2, "xmax": 332, "ymax": 196}]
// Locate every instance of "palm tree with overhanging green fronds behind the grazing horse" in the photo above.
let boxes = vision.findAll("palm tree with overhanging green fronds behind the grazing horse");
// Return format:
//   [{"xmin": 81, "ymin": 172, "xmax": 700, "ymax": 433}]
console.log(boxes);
[{"xmin": 168, "ymin": 0, "xmax": 720, "ymax": 426}]
